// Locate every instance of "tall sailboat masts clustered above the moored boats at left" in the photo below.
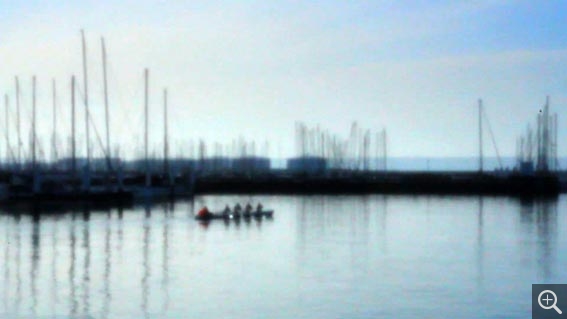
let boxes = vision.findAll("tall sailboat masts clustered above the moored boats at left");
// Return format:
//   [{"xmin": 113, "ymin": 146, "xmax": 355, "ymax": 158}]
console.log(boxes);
[{"xmin": 4, "ymin": 30, "xmax": 171, "ymax": 192}]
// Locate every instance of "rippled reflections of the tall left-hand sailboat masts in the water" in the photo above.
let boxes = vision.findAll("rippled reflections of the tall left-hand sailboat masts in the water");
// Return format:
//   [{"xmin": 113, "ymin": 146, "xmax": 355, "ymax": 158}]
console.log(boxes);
[{"xmin": 0, "ymin": 201, "xmax": 162, "ymax": 318}]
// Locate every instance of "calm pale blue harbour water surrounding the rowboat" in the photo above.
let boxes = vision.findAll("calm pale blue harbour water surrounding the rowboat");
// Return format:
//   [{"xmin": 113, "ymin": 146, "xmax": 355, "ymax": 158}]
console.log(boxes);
[{"xmin": 0, "ymin": 196, "xmax": 567, "ymax": 318}]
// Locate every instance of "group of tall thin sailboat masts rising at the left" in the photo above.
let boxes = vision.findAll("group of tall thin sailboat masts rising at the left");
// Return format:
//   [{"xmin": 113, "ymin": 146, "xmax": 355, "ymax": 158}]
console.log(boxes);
[{"xmin": 5, "ymin": 30, "xmax": 173, "ymax": 193}]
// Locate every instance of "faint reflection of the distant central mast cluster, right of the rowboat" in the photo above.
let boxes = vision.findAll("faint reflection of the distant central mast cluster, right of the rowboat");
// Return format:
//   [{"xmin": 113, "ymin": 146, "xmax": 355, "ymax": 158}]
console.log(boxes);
[{"xmin": 297, "ymin": 196, "xmax": 387, "ymax": 275}]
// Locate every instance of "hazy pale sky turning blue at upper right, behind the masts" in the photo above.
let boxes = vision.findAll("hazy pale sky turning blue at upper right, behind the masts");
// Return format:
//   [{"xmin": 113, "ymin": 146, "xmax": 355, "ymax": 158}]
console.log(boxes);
[{"xmin": 0, "ymin": 0, "xmax": 567, "ymax": 160}]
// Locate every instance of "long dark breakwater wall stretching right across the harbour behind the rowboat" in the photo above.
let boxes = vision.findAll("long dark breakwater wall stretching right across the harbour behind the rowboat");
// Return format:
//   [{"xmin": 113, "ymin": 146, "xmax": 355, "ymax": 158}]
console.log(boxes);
[{"xmin": 195, "ymin": 172, "xmax": 561, "ymax": 196}]
